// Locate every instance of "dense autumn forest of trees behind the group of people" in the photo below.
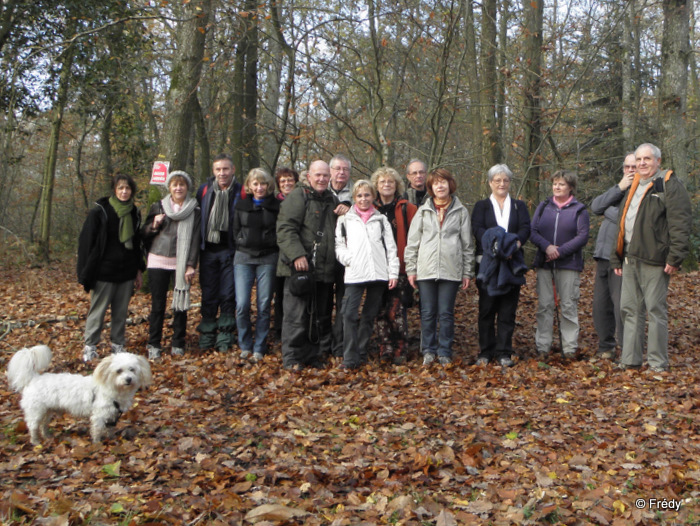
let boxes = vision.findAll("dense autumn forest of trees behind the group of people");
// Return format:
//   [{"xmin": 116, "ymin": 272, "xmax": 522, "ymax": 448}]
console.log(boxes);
[{"xmin": 0, "ymin": 0, "xmax": 700, "ymax": 262}]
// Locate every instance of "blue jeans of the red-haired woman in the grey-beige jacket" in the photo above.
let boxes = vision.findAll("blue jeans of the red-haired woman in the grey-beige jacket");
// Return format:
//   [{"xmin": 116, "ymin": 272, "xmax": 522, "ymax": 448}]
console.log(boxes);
[{"xmin": 417, "ymin": 279, "xmax": 462, "ymax": 358}]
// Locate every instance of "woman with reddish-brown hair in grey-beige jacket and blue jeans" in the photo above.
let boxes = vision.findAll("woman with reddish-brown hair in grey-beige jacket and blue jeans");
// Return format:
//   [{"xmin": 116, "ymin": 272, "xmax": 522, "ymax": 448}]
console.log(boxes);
[{"xmin": 404, "ymin": 168, "xmax": 474, "ymax": 365}]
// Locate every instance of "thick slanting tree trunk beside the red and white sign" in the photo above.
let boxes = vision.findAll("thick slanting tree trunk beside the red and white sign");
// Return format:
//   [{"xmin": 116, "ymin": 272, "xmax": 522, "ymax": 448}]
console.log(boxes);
[{"xmin": 161, "ymin": 0, "xmax": 212, "ymax": 170}]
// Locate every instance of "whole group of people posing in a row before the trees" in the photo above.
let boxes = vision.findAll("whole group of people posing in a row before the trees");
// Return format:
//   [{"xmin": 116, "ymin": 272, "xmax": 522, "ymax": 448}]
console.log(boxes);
[{"xmin": 78, "ymin": 143, "xmax": 691, "ymax": 371}]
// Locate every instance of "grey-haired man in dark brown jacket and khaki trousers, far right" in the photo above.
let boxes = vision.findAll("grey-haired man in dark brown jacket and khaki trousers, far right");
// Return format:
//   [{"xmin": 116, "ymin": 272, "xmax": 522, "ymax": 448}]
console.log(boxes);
[{"xmin": 610, "ymin": 143, "xmax": 693, "ymax": 373}]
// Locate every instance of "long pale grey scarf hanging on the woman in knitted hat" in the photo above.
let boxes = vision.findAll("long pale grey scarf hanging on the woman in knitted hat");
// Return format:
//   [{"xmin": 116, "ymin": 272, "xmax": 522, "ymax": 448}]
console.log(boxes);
[{"xmin": 161, "ymin": 195, "xmax": 197, "ymax": 311}]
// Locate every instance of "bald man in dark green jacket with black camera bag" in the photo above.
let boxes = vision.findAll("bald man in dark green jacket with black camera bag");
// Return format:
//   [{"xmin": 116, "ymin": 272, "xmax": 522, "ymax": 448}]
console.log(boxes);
[{"xmin": 277, "ymin": 161, "xmax": 338, "ymax": 371}]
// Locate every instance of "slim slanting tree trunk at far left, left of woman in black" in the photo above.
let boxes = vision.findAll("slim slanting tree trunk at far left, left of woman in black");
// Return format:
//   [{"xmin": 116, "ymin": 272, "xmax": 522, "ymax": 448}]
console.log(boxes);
[{"xmin": 37, "ymin": 34, "xmax": 75, "ymax": 263}]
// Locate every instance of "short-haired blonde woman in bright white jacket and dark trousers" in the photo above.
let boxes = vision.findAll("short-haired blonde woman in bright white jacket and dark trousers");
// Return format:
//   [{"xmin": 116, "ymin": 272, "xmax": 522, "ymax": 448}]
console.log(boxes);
[{"xmin": 335, "ymin": 180, "xmax": 399, "ymax": 369}]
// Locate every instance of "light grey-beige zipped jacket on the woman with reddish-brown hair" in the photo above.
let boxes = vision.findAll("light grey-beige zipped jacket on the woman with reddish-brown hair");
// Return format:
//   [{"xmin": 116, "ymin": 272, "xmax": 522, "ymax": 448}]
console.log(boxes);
[{"xmin": 404, "ymin": 195, "xmax": 474, "ymax": 282}]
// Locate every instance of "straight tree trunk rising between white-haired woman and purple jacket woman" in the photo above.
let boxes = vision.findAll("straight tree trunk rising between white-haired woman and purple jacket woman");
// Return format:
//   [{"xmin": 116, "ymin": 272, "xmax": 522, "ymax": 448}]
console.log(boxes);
[{"xmin": 523, "ymin": 0, "xmax": 544, "ymax": 209}]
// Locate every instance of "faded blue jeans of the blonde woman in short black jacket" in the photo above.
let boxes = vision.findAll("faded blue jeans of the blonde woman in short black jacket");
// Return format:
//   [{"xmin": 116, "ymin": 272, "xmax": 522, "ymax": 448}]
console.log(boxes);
[{"xmin": 233, "ymin": 264, "xmax": 276, "ymax": 354}]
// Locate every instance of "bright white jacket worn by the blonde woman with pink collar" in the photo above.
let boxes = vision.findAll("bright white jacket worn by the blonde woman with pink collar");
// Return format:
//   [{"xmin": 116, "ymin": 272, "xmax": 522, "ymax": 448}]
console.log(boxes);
[{"xmin": 335, "ymin": 206, "xmax": 399, "ymax": 283}]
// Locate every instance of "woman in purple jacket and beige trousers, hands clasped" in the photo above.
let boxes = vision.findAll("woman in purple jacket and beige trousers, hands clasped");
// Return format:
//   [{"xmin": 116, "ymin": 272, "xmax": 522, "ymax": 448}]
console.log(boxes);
[{"xmin": 530, "ymin": 170, "xmax": 590, "ymax": 358}]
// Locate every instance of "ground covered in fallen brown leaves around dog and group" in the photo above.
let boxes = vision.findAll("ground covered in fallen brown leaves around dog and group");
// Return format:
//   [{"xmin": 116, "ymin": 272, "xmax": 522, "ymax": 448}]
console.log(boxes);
[{"xmin": 0, "ymin": 262, "xmax": 700, "ymax": 526}]
